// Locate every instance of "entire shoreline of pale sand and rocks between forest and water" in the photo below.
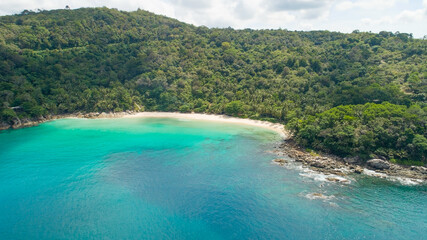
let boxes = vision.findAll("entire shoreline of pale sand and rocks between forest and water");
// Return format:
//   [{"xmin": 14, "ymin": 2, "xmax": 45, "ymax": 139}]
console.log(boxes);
[{"xmin": 0, "ymin": 111, "xmax": 427, "ymax": 185}]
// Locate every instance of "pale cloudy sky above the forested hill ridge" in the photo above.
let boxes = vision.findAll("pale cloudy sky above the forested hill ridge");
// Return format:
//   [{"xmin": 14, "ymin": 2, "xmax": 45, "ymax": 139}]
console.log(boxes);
[{"xmin": 0, "ymin": 0, "xmax": 427, "ymax": 38}]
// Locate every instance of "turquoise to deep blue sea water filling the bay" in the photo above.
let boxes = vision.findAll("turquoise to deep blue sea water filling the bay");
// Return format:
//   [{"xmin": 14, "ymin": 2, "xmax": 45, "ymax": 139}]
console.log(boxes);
[{"xmin": 0, "ymin": 118, "xmax": 427, "ymax": 240}]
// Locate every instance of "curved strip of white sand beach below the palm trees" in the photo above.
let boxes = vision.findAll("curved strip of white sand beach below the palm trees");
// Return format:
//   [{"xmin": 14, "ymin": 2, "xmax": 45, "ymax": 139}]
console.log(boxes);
[{"xmin": 123, "ymin": 112, "xmax": 289, "ymax": 139}]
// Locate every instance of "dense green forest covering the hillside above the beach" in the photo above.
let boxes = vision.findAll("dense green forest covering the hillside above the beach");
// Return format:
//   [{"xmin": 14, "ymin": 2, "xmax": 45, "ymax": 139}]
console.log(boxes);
[{"xmin": 0, "ymin": 8, "xmax": 427, "ymax": 164}]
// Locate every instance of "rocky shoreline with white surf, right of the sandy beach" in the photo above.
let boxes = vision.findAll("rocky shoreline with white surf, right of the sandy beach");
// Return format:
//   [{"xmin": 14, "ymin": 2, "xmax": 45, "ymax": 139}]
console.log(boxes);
[{"xmin": 273, "ymin": 139, "xmax": 427, "ymax": 183}]
